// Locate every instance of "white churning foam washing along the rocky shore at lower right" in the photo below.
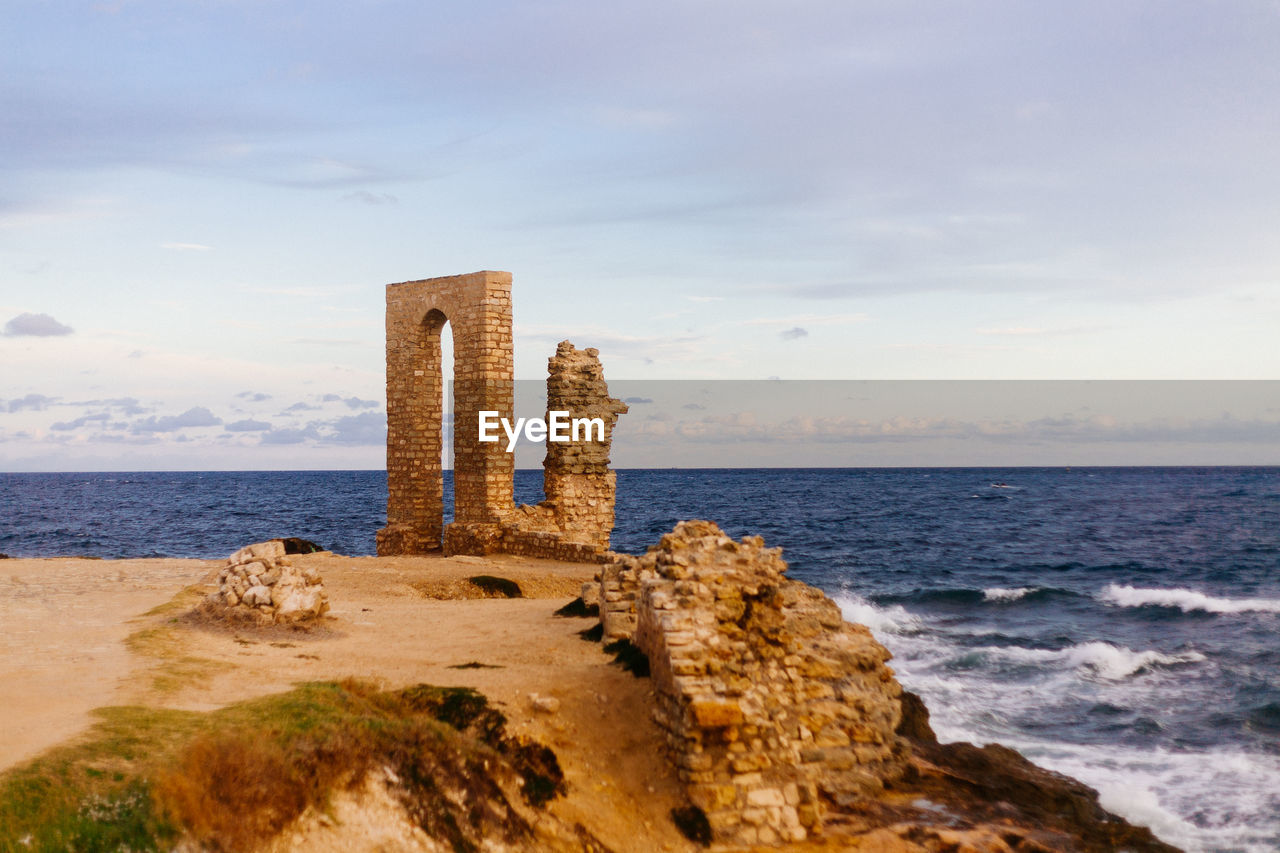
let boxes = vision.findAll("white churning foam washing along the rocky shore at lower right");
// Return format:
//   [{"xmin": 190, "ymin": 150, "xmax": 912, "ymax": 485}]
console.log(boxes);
[{"xmin": 836, "ymin": 594, "xmax": 1280, "ymax": 853}]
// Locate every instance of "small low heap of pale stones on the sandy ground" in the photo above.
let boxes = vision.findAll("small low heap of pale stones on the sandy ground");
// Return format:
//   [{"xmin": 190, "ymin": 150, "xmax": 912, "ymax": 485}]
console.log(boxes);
[{"xmin": 206, "ymin": 539, "xmax": 329, "ymax": 624}]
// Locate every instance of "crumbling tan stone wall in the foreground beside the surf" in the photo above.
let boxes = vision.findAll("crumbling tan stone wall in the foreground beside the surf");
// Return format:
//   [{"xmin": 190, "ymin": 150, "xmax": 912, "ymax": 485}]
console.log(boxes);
[{"xmin": 600, "ymin": 521, "xmax": 906, "ymax": 844}]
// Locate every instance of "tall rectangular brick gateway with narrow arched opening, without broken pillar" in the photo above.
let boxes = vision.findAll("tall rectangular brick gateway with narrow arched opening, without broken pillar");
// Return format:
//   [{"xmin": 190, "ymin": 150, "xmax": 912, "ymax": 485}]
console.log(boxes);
[{"xmin": 378, "ymin": 272, "xmax": 515, "ymax": 556}]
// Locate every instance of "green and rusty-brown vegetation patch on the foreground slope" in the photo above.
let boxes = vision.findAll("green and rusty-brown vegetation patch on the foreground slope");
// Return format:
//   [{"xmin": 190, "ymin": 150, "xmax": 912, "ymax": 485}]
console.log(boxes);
[{"xmin": 0, "ymin": 680, "xmax": 563, "ymax": 850}]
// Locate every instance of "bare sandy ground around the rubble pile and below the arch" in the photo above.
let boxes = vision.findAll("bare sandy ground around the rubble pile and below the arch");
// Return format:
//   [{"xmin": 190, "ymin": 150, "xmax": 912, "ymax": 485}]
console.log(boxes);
[{"xmin": 0, "ymin": 553, "xmax": 692, "ymax": 852}]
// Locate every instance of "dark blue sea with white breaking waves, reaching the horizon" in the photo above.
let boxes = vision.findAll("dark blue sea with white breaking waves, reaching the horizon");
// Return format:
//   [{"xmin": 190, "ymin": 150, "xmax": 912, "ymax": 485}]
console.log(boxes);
[{"xmin": 0, "ymin": 467, "xmax": 1280, "ymax": 853}]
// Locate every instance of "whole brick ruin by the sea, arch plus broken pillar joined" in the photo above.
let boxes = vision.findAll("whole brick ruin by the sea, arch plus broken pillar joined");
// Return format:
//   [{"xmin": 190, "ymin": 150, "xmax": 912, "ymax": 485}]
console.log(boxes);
[{"xmin": 378, "ymin": 272, "xmax": 627, "ymax": 561}]
